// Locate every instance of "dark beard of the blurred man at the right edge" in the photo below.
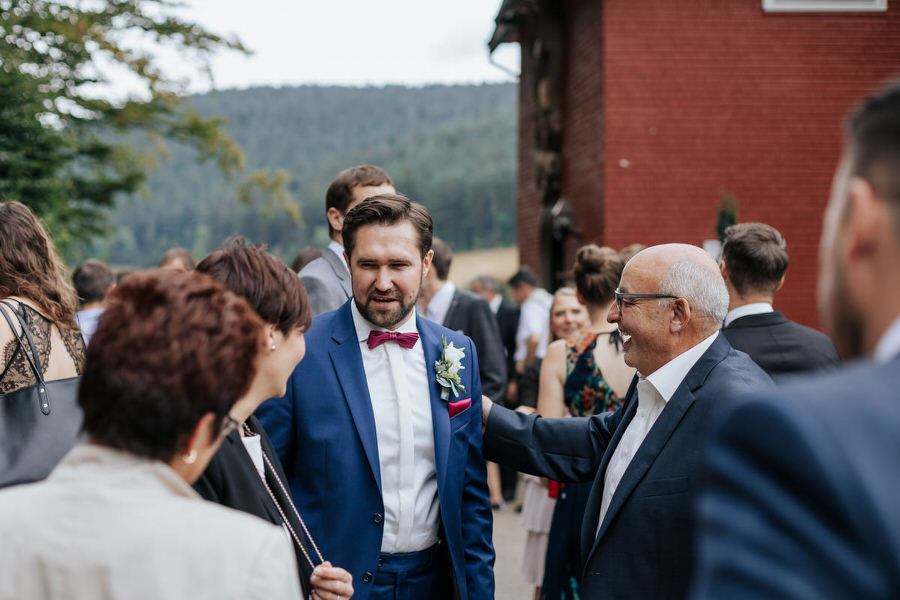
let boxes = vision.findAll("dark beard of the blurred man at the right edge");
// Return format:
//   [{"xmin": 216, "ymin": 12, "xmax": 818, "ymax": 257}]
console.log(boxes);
[{"xmin": 819, "ymin": 257, "xmax": 865, "ymax": 360}]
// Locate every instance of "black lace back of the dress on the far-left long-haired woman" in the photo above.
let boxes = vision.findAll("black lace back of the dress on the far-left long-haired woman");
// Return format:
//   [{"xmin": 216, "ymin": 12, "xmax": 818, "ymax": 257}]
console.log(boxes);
[{"xmin": 0, "ymin": 302, "xmax": 84, "ymax": 394}]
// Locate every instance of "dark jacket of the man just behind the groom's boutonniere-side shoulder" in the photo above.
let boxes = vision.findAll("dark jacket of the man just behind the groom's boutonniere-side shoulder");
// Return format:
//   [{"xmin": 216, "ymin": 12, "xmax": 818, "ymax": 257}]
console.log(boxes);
[{"xmin": 442, "ymin": 290, "xmax": 506, "ymax": 403}]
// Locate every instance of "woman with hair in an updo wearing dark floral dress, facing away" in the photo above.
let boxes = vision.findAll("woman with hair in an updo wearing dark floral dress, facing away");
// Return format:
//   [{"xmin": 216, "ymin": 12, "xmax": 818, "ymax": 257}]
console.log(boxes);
[{"xmin": 538, "ymin": 244, "xmax": 634, "ymax": 600}]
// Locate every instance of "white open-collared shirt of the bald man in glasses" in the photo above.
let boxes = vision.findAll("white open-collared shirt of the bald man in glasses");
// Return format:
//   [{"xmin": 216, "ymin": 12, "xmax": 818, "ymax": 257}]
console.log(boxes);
[{"xmin": 595, "ymin": 331, "xmax": 719, "ymax": 535}]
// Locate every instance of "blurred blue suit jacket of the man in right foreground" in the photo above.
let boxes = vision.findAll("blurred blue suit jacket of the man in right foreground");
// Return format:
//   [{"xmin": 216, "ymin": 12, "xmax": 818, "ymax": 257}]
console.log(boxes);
[{"xmin": 694, "ymin": 360, "xmax": 900, "ymax": 600}]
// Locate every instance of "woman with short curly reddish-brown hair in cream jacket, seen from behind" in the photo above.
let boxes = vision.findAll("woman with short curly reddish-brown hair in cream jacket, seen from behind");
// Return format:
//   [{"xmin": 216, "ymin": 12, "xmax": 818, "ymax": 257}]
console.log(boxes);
[{"xmin": 0, "ymin": 270, "xmax": 300, "ymax": 600}]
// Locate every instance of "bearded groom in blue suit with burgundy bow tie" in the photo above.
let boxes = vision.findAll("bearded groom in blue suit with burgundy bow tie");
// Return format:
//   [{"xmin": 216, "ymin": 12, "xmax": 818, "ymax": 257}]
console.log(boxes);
[{"xmin": 257, "ymin": 194, "xmax": 494, "ymax": 600}]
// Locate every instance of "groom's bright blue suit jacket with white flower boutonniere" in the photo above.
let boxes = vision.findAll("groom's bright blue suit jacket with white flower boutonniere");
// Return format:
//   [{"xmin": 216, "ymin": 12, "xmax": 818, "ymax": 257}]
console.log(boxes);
[{"xmin": 257, "ymin": 299, "xmax": 494, "ymax": 600}]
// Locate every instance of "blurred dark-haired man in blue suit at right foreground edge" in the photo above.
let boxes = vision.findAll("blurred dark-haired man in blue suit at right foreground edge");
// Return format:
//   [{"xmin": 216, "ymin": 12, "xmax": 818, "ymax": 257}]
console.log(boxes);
[{"xmin": 694, "ymin": 84, "xmax": 900, "ymax": 599}]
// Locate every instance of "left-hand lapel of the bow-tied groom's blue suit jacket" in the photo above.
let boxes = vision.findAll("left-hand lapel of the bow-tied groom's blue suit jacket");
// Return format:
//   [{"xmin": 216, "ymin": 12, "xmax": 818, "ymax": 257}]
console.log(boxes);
[{"xmin": 327, "ymin": 304, "xmax": 381, "ymax": 491}]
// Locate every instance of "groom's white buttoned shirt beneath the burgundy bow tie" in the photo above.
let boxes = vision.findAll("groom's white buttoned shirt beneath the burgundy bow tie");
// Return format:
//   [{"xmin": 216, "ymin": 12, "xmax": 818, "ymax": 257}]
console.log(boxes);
[{"xmin": 350, "ymin": 302, "xmax": 439, "ymax": 553}]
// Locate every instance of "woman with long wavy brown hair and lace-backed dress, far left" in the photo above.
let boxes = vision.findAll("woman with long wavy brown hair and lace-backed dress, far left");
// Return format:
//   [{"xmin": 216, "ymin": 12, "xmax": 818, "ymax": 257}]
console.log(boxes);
[{"xmin": 0, "ymin": 202, "xmax": 85, "ymax": 487}]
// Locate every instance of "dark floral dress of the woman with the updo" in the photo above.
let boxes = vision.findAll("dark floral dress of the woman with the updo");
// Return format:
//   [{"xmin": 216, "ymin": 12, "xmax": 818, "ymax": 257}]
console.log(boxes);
[{"xmin": 542, "ymin": 331, "xmax": 622, "ymax": 600}]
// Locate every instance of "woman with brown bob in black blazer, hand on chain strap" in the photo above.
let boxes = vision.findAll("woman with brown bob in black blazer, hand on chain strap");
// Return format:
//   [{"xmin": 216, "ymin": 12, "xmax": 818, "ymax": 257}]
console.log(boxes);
[{"xmin": 194, "ymin": 238, "xmax": 353, "ymax": 598}]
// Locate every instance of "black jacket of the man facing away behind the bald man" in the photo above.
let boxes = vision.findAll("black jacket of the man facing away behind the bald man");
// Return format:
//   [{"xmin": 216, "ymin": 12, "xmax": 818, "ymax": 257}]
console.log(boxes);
[{"xmin": 722, "ymin": 311, "xmax": 841, "ymax": 381}]
